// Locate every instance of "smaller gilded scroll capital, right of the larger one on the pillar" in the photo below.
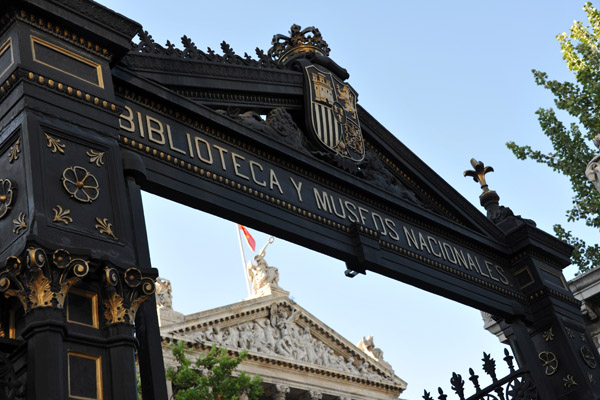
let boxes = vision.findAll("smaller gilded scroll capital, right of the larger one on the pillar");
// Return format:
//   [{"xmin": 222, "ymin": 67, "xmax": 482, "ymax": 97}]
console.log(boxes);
[{"xmin": 103, "ymin": 267, "xmax": 155, "ymax": 325}]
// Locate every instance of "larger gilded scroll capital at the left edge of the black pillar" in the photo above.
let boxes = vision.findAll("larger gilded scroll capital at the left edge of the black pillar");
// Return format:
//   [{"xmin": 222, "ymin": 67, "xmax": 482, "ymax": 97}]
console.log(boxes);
[{"xmin": 0, "ymin": 247, "xmax": 90, "ymax": 312}]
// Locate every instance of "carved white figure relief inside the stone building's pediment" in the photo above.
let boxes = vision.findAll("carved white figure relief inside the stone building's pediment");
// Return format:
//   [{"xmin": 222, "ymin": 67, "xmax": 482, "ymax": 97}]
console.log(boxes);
[{"xmin": 194, "ymin": 304, "xmax": 394, "ymax": 383}]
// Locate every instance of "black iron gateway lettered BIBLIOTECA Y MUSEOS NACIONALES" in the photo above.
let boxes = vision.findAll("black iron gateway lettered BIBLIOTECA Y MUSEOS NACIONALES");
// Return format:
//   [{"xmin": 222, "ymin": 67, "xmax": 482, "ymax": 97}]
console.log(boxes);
[{"xmin": 0, "ymin": 0, "xmax": 600, "ymax": 399}]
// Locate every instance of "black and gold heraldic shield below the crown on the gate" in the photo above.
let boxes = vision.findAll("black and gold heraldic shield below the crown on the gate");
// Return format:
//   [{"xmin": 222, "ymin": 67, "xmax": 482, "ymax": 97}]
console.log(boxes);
[{"xmin": 304, "ymin": 65, "xmax": 365, "ymax": 161}]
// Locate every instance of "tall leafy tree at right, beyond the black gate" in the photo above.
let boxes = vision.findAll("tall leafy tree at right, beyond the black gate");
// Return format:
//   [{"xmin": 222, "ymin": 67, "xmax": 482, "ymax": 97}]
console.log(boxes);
[{"xmin": 506, "ymin": 2, "xmax": 600, "ymax": 272}]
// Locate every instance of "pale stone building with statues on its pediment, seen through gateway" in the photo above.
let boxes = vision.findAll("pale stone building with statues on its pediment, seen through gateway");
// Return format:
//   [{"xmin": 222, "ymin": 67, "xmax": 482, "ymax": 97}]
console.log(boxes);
[{"xmin": 156, "ymin": 254, "xmax": 407, "ymax": 400}]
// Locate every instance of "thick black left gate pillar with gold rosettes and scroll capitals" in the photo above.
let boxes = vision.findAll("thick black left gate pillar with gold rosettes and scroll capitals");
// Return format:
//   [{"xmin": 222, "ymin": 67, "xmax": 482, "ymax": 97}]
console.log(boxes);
[{"xmin": 0, "ymin": 0, "xmax": 166, "ymax": 400}]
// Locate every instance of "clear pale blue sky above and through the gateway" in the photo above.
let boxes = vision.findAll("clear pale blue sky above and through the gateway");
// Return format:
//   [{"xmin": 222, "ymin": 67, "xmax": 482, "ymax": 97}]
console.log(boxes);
[{"xmin": 100, "ymin": 0, "xmax": 597, "ymax": 399}]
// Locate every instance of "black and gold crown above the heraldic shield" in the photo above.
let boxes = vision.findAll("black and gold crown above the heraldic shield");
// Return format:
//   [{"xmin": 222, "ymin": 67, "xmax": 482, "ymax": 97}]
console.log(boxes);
[{"xmin": 268, "ymin": 24, "xmax": 329, "ymax": 64}]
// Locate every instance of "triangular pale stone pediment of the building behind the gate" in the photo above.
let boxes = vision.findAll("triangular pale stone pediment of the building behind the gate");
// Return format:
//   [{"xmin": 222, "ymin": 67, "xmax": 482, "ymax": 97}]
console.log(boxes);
[{"xmin": 161, "ymin": 292, "xmax": 406, "ymax": 388}]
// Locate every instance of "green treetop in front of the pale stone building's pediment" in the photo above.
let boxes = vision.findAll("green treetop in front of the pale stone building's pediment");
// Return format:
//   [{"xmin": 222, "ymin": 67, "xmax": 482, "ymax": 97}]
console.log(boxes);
[{"xmin": 167, "ymin": 342, "xmax": 263, "ymax": 400}]
